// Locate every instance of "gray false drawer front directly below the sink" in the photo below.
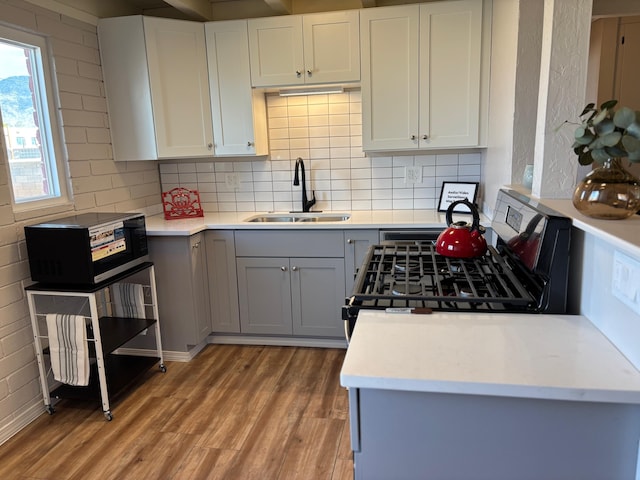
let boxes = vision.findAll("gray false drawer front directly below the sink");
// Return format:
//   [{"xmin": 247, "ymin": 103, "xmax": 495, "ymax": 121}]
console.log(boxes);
[{"xmin": 236, "ymin": 230, "xmax": 344, "ymax": 258}]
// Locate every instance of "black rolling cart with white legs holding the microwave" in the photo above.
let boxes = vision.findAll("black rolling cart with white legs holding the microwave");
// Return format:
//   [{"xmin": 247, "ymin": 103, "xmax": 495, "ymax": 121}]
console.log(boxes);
[{"xmin": 25, "ymin": 262, "xmax": 166, "ymax": 420}]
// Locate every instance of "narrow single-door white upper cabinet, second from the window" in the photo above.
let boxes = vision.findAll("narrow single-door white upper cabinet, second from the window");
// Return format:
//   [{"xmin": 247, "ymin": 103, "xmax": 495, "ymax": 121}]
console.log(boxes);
[{"xmin": 205, "ymin": 20, "xmax": 269, "ymax": 156}]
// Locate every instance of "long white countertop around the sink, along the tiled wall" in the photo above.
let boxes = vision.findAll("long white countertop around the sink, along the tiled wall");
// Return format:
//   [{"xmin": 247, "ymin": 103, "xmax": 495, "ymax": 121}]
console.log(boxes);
[{"xmin": 146, "ymin": 210, "xmax": 460, "ymax": 236}]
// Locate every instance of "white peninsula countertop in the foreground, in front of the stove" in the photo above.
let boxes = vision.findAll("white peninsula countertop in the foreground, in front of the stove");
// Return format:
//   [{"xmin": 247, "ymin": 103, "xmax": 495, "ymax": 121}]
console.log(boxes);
[{"xmin": 340, "ymin": 310, "xmax": 640, "ymax": 403}]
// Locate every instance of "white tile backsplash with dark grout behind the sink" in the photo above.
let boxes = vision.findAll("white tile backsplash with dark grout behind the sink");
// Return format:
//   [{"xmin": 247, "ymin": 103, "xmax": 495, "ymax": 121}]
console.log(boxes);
[{"xmin": 160, "ymin": 90, "xmax": 482, "ymax": 212}]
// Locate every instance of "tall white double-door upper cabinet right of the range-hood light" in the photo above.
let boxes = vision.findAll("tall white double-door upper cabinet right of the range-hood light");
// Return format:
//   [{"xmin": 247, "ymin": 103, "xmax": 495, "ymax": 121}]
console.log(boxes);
[{"xmin": 360, "ymin": 0, "xmax": 483, "ymax": 151}]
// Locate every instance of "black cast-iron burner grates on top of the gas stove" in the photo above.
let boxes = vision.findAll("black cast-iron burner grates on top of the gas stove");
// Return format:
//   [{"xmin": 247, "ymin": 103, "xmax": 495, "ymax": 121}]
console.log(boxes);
[{"xmin": 354, "ymin": 244, "xmax": 535, "ymax": 311}]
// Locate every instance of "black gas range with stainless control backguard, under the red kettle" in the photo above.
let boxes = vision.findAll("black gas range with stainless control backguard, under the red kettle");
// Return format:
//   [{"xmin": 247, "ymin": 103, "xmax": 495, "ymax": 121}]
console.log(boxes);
[{"xmin": 342, "ymin": 190, "xmax": 571, "ymax": 338}]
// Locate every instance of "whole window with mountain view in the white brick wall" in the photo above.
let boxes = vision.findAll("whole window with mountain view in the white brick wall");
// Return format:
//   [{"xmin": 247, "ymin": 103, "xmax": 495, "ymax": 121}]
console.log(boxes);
[{"xmin": 0, "ymin": 26, "xmax": 67, "ymax": 211}]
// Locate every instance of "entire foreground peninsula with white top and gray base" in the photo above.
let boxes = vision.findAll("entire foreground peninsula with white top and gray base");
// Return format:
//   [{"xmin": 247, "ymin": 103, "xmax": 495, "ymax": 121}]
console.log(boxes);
[{"xmin": 340, "ymin": 310, "xmax": 640, "ymax": 480}]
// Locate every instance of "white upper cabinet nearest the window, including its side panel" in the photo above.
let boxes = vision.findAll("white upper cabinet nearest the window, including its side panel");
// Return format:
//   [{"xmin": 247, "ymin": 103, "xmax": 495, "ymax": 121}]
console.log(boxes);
[{"xmin": 98, "ymin": 16, "xmax": 213, "ymax": 160}]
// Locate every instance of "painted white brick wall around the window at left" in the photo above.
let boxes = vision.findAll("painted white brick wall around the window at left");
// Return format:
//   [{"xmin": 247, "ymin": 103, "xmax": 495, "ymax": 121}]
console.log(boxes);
[{"xmin": 0, "ymin": 0, "xmax": 161, "ymax": 444}]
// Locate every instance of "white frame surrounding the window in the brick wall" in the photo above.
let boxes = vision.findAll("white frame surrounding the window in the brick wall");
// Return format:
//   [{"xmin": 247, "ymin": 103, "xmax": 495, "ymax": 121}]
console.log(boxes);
[{"xmin": 0, "ymin": 25, "xmax": 72, "ymax": 217}]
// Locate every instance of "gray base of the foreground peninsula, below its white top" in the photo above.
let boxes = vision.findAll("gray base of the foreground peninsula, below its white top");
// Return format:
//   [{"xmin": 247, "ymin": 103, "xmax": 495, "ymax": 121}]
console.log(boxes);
[{"xmin": 349, "ymin": 387, "xmax": 640, "ymax": 480}]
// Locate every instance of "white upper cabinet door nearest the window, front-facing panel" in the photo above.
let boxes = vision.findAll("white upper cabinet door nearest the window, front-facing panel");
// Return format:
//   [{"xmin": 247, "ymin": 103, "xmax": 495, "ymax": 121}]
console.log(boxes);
[{"xmin": 144, "ymin": 17, "xmax": 213, "ymax": 158}]
